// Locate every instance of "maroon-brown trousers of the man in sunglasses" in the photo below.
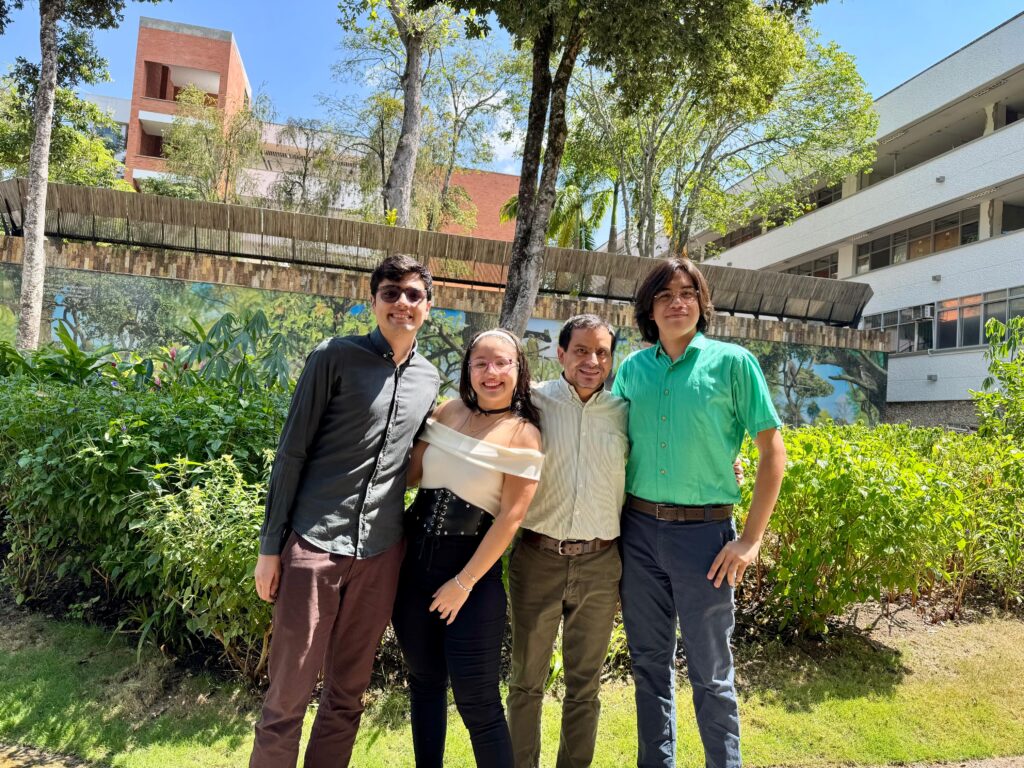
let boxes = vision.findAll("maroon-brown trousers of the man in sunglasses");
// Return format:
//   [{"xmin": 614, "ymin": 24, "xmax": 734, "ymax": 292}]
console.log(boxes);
[{"xmin": 249, "ymin": 534, "xmax": 406, "ymax": 768}]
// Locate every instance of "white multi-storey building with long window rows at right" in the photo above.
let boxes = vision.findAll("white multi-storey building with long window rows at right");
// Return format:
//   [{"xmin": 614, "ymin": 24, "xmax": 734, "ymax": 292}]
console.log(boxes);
[{"xmin": 695, "ymin": 13, "xmax": 1024, "ymax": 426}]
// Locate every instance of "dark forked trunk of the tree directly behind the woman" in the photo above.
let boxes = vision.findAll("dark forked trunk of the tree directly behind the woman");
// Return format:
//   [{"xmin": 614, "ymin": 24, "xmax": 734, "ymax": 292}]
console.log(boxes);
[{"xmin": 499, "ymin": 16, "xmax": 583, "ymax": 336}]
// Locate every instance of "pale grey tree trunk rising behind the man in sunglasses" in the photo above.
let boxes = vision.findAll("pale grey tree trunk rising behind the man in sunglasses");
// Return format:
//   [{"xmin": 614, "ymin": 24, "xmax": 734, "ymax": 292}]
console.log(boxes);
[{"xmin": 384, "ymin": 10, "xmax": 423, "ymax": 226}]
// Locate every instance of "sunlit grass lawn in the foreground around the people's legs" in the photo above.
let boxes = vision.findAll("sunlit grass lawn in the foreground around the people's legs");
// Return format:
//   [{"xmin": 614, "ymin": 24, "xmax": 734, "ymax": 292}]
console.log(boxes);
[{"xmin": 0, "ymin": 612, "xmax": 1024, "ymax": 768}]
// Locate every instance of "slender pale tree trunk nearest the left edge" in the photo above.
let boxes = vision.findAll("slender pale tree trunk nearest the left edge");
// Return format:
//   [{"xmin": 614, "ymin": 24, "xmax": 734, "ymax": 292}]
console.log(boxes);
[{"xmin": 15, "ymin": 0, "xmax": 60, "ymax": 349}]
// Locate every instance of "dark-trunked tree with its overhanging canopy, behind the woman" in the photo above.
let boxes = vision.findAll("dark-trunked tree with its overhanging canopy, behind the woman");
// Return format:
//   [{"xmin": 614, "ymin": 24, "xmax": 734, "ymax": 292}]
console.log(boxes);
[{"xmin": 414, "ymin": 0, "xmax": 827, "ymax": 333}]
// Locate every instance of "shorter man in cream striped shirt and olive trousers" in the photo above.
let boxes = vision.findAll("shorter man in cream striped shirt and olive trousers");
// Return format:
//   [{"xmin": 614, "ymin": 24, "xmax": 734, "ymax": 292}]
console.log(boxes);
[{"xmin": 508, "ymin": 314, "xmax": 629, "ymax": 768}]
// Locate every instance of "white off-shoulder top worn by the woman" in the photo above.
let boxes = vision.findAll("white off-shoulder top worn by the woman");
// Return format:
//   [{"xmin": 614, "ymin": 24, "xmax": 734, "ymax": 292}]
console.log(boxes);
[{"xmin": 420, "ymin": 419, "xmax": 544, "ymax": 515}]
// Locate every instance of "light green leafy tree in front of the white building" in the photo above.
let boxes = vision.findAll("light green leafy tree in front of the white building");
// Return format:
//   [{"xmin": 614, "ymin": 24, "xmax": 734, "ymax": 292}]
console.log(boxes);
[{"xmin": 570, "ymin": 12, "xmax": 877, "ymax": 257}]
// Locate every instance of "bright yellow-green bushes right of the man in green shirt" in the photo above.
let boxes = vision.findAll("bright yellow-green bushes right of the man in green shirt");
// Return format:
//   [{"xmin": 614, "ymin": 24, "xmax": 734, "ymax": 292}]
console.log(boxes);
[{"xmin": 739, "ymin": 425, "xmax": 1024, "ymax": 634}]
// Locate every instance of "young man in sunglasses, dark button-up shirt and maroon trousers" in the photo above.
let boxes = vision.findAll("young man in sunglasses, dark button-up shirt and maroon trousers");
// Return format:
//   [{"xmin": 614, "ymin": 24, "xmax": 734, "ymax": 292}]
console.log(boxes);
[{"xmin": 250, "ymin": 256, "xmax": 439, "ymax": 768}]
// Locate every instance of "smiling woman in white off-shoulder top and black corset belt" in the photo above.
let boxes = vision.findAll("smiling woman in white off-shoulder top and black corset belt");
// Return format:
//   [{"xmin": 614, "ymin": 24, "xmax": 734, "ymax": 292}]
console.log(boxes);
[{"xmin": 392, "ymin": 329, "xmax": 544, "ymax": 768}]
